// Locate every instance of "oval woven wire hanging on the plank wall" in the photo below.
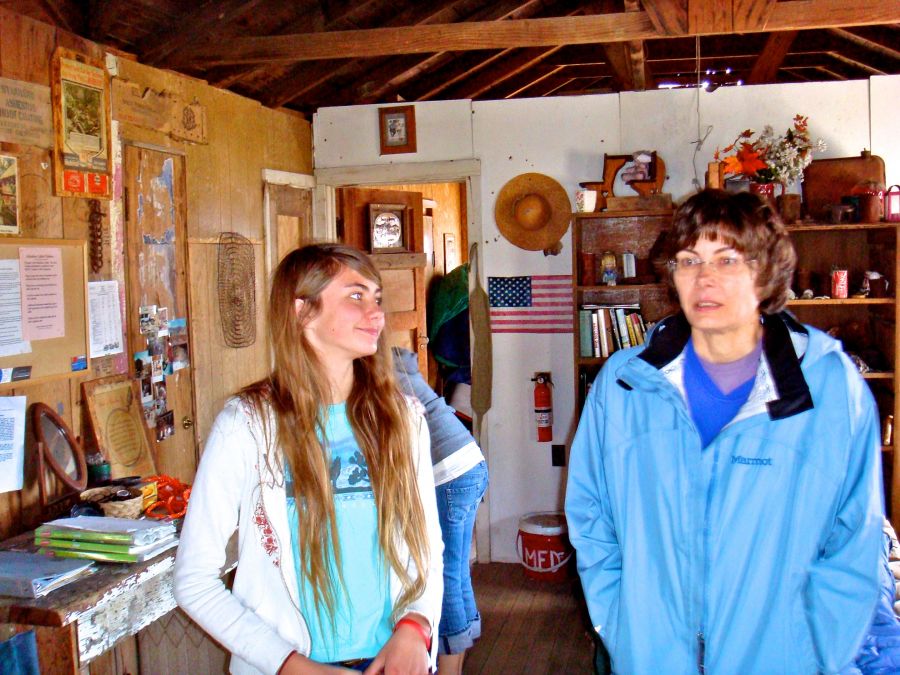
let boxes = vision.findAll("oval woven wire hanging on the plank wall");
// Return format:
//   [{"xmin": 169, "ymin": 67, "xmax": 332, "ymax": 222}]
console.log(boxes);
[{"xmin": 218, "ymin": 232, "xmax": 256, "ymax": 347}]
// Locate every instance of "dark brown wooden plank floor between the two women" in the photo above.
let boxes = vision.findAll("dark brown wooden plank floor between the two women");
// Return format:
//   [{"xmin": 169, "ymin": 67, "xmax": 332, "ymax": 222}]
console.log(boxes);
[{"xmin": 463, "ymin": 563, "xmax": 593, "ymax": 675}]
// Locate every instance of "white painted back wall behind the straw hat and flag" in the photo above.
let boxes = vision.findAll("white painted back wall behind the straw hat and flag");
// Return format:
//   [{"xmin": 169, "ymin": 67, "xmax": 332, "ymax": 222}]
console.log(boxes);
[{"xmin": 313, "ymin": 76, "xmax": 900, "ymax": 562}]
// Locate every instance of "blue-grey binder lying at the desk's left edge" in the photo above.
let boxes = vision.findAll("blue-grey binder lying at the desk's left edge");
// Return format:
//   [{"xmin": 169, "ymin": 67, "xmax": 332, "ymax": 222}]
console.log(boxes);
[{"xmin": 0, "ymin": 551, "xmax": 94, "ymax": 598}]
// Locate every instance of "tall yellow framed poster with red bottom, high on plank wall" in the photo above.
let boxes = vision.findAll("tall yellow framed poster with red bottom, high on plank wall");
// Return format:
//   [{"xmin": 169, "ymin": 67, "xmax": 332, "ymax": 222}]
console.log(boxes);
[{"xmin": 51, "ymin": 47, "xmax": 112, "ymax": 199}]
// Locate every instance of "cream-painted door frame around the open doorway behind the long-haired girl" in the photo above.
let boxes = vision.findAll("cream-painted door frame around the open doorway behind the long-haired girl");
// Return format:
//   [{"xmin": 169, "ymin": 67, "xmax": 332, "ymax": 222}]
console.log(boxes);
[{"xmin": 313, "ymin": 159, "xmax": 491, "ymax": 563}]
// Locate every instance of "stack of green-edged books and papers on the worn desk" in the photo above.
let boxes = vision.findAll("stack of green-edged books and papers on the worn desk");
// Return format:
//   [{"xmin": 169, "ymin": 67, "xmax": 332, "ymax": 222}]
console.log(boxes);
[{"xmin": 34, "ymin": 516, "xmax": 178, "ymax": 563}]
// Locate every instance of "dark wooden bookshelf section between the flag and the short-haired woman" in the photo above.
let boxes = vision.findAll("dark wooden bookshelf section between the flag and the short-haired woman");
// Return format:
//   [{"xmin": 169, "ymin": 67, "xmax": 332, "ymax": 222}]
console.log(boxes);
[{"xmin": 572, "ymin": 209, "xmax": 677, "ymax": 411}]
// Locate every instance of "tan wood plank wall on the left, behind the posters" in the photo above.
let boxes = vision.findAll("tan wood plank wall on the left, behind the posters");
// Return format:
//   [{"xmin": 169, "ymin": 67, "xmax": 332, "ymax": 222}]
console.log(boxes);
[{"xmin": 0, "ymin": 7, "xmax": 312, "ymax": 538}]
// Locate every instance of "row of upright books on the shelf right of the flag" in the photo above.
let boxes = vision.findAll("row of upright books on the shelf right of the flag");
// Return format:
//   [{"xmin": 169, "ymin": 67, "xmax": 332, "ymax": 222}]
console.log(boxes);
[{"xmin": 578, "ymin": 303, "xmax": 647, "ymax": 357}]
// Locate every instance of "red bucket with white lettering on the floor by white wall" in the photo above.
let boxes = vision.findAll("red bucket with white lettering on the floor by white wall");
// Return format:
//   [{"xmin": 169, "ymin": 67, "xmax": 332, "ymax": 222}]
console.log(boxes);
[{"xmin": 516, "ymin": 512, "xmax": 573, "ymax": 581}]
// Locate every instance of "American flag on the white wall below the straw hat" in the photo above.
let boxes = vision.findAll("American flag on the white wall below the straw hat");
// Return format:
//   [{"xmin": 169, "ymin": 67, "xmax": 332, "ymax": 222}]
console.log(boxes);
[{"xmin": 488, "ymin": 274, "xmax": 572, "ymax": 333}]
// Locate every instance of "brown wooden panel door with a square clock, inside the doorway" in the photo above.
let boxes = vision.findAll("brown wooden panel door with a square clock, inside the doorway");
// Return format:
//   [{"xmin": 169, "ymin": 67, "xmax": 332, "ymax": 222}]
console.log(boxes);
[{"xmin": 337, "ymin": 188, "xmax": 428, "ymax": 380}]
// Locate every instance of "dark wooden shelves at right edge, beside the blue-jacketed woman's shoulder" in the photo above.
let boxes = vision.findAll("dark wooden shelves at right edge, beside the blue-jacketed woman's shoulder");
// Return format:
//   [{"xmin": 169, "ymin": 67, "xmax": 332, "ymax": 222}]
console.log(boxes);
[{"xmin": 787, "ymin": 222, "xmax": 900, "ymax": 522}]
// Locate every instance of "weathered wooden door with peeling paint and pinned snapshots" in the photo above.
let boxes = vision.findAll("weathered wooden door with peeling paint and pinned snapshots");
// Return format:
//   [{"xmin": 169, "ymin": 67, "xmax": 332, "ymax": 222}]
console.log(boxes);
[{"xmin": 124, "ymin": 145, "xmax": 198, "ymax": 482}]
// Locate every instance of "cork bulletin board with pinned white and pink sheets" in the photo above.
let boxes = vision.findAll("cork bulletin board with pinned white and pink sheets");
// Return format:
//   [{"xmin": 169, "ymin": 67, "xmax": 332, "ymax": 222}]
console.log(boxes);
[{"xmin": 0, "ymin": 238, "xmax": 90, "ymax": 392}]
